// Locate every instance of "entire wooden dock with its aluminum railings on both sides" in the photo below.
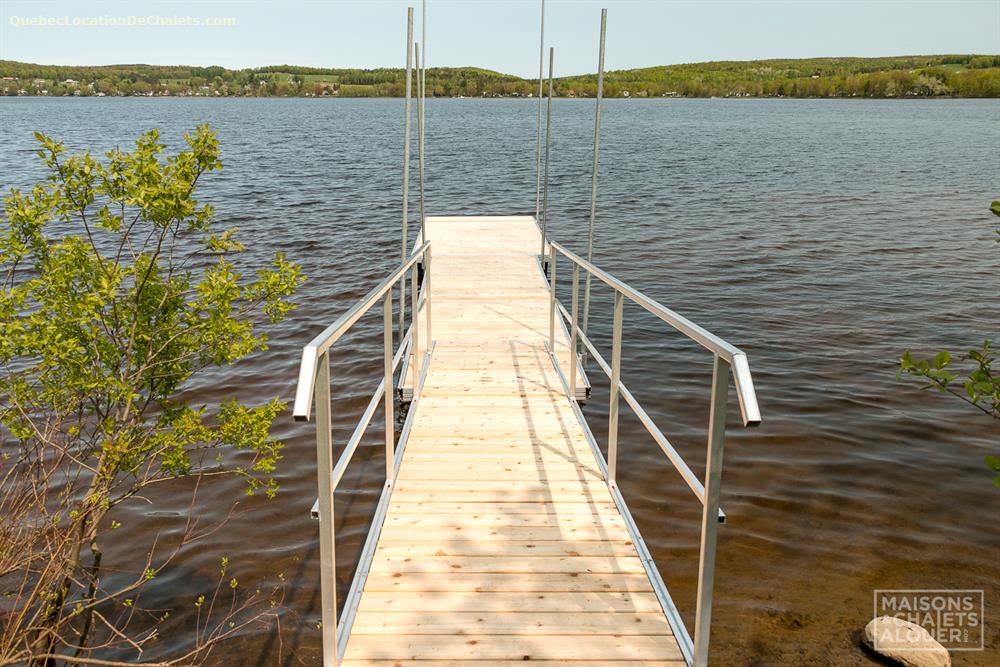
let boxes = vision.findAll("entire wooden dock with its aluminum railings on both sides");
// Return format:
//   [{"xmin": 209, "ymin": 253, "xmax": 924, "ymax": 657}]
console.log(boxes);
[{"xmin": 293, "ymin": 216, "xmax": 760, "ymax": 667}]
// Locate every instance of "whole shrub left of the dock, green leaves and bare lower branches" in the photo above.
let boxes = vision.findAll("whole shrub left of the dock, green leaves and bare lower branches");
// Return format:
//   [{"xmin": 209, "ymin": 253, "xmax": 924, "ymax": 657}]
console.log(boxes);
[{"xmin": 0, "ymin": 126, "xmax": 302, "ymax": 666}]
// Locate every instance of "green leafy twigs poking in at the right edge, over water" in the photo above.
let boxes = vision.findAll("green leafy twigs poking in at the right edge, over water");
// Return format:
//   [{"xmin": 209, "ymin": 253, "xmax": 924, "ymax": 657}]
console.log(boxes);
[{"xmin": 899, "ymin": 201, "xmax": 1000, "ymax": 488}]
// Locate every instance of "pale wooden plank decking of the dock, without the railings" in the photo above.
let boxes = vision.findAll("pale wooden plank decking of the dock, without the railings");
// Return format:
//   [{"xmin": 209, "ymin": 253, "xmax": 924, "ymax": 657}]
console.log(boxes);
[{"xmin": 342, "ymin": 217, "xmax": 685, "ymax": 667}]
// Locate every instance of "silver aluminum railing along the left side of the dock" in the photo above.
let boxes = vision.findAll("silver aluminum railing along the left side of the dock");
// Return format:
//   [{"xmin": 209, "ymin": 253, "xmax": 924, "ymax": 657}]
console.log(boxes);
[{"xmin": 293, "ymin": 241, "xmax": 433, "ymax": 667}]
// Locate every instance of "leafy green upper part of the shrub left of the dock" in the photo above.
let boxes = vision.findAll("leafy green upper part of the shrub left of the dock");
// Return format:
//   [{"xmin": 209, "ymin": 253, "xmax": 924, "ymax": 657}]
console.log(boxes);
[{"xmin": 0, "ymin": 126, "xmax": 301, "ymax": 501}]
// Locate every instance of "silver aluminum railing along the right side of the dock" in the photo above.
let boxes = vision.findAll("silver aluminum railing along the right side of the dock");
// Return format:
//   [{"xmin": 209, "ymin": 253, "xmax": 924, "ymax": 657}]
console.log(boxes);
[{"xmin": 548, "ymin": 241, "xmax": 760, "ymax": 667}]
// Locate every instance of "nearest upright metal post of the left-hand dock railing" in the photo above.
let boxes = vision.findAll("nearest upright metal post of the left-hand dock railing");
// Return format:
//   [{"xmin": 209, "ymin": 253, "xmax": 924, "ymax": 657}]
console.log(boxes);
[{"xmin": 315, "ymin": 352, "xmax": 338, "ymax": 667}]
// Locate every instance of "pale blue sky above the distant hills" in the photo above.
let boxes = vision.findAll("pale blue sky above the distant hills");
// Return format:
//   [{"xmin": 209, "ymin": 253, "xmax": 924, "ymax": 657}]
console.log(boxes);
[{"xmin": 0, "ymin": 0, "xmax": 1000, "ymax": 76}]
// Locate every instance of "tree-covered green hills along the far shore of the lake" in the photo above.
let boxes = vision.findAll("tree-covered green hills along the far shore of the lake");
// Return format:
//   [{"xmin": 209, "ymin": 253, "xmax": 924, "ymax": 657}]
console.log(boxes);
[{"xmin": 0, "ymin": 55, "xmax": 1000, "ymax": 98}]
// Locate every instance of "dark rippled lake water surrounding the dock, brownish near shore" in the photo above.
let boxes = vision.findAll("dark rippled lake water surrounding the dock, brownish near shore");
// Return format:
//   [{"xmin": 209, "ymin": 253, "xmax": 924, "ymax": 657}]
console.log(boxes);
[{"xmin": 0, "ymin": 99, "xmax": 1000, "ymax": 665}]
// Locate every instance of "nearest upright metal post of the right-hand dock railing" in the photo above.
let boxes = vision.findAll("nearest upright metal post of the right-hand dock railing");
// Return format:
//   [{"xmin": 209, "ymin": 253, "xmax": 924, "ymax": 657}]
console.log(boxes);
[{"xmin": 694, "ymin": 355, "xmax": 729, "ymax": 667}]
